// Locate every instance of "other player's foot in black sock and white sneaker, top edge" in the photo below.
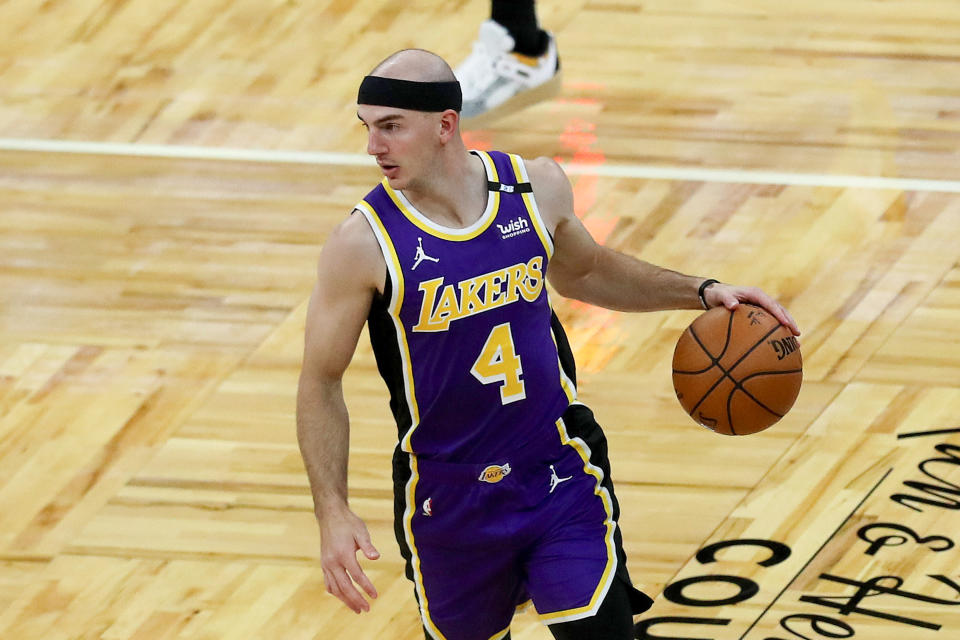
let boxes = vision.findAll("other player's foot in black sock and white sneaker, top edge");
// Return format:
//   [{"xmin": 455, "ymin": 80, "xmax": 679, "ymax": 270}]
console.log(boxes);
[{"xmin": 454, "ymin": 0, "xmax": 560, "ymax": 124}]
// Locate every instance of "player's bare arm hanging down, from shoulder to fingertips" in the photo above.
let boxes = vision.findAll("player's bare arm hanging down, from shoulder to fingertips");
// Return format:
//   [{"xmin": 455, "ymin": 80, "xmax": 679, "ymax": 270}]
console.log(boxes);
[{"xmin": 297, "ymin": 212, "xmax": 386, "ymax": 613}]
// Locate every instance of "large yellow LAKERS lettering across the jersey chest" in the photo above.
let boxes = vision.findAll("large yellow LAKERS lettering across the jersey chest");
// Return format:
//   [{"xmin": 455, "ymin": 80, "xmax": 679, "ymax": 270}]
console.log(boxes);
[{"xmin": 413, "ymin": 256, "xmax": 543, "ymax": 331}]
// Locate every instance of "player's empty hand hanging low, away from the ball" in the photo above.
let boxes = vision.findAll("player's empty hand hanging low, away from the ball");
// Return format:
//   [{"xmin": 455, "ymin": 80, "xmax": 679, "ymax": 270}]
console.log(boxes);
[{"xmin": 320, "ymin": 507, "xmax": 380, "ymax": 613}]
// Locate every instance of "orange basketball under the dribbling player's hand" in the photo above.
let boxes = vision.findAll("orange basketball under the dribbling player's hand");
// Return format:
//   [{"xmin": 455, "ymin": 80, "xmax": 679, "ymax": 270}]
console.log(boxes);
[{"xmin": 673, "ymin": 304, "xmax": 803, "ymax": 436}]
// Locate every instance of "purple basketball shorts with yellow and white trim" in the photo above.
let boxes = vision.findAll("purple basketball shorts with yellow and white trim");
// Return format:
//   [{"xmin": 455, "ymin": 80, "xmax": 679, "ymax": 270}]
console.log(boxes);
[{"xmin": 397, "ymin": 406, "xmax": 629, "ymax": 640}]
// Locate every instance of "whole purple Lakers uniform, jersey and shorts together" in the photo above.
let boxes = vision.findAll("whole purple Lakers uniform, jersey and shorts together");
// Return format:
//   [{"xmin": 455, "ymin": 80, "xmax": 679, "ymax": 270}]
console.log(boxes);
[{"xmin": 348, "ymin": 151, "xmax": 649, "ymax": 640}]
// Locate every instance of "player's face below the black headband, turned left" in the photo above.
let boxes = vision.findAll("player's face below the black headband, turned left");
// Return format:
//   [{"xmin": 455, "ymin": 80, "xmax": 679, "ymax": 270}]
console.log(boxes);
[{"xmin": 357, "ymin": 105, "xmax": 433, "ymax": 189}]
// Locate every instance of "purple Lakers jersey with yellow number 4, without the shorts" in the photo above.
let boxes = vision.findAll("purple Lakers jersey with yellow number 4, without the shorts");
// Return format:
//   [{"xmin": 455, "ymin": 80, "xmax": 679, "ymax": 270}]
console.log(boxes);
[{"xmin": 357, "ymin": 151, "xmax": 576, "ymax": 462}]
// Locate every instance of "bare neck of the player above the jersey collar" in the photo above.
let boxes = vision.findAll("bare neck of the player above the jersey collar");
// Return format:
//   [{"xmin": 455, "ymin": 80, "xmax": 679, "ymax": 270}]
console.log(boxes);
[{"xmin": 403, "ymin": 144, "xmax": 487, "ymax": 229}]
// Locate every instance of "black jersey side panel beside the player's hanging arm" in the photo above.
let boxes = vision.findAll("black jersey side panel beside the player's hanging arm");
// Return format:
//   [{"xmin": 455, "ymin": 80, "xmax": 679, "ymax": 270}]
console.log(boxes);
[{"xmin": 367, "ymin": 273, "xmax": 413, "ymax": 437}]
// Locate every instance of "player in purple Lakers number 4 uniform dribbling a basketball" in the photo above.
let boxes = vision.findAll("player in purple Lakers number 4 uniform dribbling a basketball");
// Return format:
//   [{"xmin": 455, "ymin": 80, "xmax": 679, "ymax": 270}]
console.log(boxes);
[{"xmin": 297, "ymin": 50, "xmax": 798, "ymax": 640}]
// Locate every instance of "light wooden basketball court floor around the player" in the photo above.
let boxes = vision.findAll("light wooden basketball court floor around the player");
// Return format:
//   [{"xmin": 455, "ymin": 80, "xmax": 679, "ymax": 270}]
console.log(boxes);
[{"xmin": 0, "ymin": 0, "xmax": 960, "ymax": 640}]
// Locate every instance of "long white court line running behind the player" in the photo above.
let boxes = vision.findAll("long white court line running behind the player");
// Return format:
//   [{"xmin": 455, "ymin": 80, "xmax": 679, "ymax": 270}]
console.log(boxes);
[{"xmin": 0, "ymin": 138, "xmax": 960, "ymax": 193}]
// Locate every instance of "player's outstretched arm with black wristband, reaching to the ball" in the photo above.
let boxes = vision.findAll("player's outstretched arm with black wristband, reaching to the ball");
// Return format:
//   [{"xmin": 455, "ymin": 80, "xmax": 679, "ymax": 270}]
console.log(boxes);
[{"xmin": 526, "ymin": 158, "xmax": 800, "ymax": 335}]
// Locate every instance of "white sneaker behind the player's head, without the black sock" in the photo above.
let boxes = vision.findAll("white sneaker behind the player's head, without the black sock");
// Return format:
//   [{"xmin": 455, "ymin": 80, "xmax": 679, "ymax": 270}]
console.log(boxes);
[{"xmin": 454, "ymin": 20, "xmax": 560, "ymax": 124}]
